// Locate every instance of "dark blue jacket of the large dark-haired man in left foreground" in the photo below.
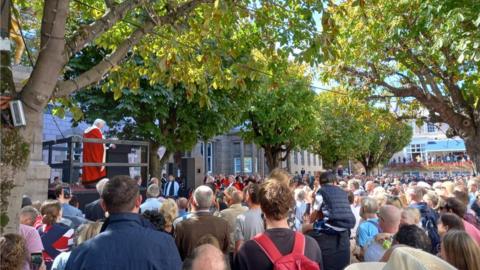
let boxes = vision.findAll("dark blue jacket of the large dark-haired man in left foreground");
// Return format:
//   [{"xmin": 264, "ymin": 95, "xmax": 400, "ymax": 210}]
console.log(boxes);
[{"xmin": 65, "ymin": 213, "xmax": 182, "ymax": 270}]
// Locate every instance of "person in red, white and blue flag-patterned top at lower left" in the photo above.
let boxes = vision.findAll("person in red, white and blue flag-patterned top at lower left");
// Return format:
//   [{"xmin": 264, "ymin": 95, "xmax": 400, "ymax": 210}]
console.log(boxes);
[{"xmin": 38, "ymin": 200, "xmax": 74, "ymax": 270}]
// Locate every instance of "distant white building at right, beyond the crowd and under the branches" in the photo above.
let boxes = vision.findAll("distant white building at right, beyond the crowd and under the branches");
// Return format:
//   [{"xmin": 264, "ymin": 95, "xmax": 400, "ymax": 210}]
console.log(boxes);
[{"xmin": 385, "ymin": 121, "xmax": 473, "ymax": 178}]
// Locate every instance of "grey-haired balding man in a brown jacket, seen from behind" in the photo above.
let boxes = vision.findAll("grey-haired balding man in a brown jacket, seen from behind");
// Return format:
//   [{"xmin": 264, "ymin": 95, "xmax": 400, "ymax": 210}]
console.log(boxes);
[{"xmin": 175, "ymin": 186, "xmax": 230, "ymax": 260}]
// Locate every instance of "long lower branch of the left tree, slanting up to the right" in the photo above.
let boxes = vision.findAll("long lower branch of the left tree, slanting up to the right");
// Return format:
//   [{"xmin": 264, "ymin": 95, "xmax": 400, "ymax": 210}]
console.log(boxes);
[{"xmin": 54, "ymin": 0, "xmax": 213, "ymax": 97}]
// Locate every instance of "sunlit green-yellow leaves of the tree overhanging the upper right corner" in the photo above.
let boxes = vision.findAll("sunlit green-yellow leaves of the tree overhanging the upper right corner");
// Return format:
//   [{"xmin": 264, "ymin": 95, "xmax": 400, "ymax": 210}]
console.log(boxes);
[{"xmin": 322, "ymin": 0, "xmax": 480, "ymax": 114}]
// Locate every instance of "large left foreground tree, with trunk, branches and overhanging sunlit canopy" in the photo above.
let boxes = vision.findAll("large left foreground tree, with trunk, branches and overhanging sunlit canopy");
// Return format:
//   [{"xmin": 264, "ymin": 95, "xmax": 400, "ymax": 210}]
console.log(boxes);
[{"xmin": 2, "ymin": 0, "xmax": 322, "ymax": 231}]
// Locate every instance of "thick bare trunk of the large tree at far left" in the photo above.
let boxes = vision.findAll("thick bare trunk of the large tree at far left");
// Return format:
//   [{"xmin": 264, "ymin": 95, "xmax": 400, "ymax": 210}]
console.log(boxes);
[{"xmin": 2, "ymin": 0, "xmax": 69, "ymax": 232}]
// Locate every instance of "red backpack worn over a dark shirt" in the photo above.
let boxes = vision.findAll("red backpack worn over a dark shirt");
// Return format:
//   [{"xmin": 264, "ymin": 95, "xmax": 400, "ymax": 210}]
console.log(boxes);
[{"xmin": 254, "ymin": 232, "xmax": 320, "ymax": 270}]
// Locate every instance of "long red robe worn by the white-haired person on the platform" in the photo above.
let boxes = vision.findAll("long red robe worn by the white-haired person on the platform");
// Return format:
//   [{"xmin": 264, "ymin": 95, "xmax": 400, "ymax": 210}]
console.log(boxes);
[{"xmin": 82, "ymin": 128, "xmax": 107, "ymax": 184}]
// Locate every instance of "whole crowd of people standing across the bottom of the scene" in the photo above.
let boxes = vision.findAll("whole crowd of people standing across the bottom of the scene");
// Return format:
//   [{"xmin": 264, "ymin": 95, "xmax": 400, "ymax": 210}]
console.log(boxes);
[{"xmin": 0, "ymin": 169, "xmax": 480, "ymax": 270}]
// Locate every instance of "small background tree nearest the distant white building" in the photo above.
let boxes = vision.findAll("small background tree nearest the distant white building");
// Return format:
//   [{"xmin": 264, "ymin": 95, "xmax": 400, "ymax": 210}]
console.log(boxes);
[{"xmin": 355, "ymin": 108, "xmax": 412, "ymax": 175}]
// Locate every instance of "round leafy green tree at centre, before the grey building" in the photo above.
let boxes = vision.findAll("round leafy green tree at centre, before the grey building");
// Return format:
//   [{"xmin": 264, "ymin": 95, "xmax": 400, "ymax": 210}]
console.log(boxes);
[{"xmin": 241, "ymin": 63, "xmax": 315, "ymax": 170}]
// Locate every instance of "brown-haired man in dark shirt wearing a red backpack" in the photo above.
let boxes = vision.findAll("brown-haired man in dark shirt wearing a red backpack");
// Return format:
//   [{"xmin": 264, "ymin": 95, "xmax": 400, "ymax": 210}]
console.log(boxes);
[{"xmin": 234, "ymin": 178, "xmax": 322, "ymax": 270}]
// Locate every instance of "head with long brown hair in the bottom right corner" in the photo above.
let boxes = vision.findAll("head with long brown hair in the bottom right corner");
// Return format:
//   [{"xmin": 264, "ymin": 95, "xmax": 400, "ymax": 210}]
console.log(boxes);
[{"xmin": 440, "ymin": 230, "xmax": 480, "ymax": 270}]
